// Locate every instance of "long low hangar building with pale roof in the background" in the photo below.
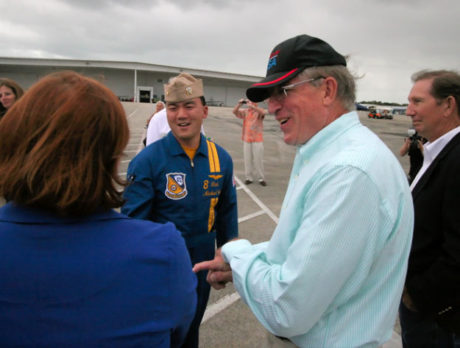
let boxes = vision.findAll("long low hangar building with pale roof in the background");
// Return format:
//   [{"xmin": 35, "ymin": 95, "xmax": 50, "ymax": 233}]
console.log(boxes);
[{"xmin": 0, "ymin": 57, "xmax": 261, "ymax": 106}]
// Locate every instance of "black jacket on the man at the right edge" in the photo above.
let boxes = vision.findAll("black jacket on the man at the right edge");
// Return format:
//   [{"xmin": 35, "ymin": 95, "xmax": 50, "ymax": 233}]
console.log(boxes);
[{"xmin": 406, "ymin": 134, "xmax": 460, "ymax": 333}]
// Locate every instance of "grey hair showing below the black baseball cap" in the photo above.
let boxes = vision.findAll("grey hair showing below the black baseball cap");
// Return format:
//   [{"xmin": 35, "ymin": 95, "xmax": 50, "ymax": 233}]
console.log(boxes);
[{"xmin": 298, "ymin": 65, "xmax": 356, "ymax": 111}]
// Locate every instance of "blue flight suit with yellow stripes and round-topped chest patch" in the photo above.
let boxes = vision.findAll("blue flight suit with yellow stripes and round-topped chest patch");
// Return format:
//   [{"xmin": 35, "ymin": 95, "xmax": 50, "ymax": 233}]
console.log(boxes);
[{"xmin": 121, "ymin": 132, "xmax": 238, "ymax": 347}]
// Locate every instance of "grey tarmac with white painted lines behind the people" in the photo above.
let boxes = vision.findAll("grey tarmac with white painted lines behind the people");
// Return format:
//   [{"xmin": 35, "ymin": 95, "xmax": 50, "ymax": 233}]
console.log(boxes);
[{"xmin": 120, "ymin": 103, "xmax": 411, "ymax": 348}]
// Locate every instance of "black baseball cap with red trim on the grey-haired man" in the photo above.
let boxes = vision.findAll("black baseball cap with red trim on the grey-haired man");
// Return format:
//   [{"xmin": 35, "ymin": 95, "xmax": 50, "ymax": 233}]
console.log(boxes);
[{"xmin": 246, "ymin": 35, "xmax": 347, "ymax": 102}]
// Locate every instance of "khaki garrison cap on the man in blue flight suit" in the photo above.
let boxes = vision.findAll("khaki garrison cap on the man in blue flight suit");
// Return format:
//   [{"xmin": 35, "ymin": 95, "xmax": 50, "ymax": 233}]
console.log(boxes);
[{"xmin": 164, "ymin": 73, "xmax": 203, "ymax": 103}]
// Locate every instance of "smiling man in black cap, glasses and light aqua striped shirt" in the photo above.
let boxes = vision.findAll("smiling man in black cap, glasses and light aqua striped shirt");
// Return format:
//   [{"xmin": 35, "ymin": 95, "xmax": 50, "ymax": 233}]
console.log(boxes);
[{"xmin": 194, "ymin": 35, "xmax": 413, "ymax": 347}]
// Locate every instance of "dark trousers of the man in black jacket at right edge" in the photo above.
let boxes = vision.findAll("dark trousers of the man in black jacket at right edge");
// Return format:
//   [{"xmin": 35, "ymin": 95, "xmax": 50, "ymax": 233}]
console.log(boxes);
[{"xmin": 399, "ymin": 302, "xmax": 460, "ymax": 348}]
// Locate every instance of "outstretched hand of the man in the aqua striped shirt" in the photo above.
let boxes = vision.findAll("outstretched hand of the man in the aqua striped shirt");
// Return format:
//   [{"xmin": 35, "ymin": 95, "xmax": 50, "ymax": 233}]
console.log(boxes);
[{"xmin": 193, "ymin": 248, "xmax": 233, "ymax": 290}]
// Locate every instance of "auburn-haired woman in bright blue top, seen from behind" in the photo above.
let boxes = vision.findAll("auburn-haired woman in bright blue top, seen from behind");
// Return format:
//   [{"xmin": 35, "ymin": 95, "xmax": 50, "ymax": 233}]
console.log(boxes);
[{"xmin": 0, "ymin": 72, "xmax": 196, "ymax": 347}]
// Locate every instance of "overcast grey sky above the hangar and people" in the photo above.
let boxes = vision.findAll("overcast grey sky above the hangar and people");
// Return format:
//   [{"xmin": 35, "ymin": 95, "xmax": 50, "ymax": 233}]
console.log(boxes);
[{"xmin": 0, "ymin": 0, "xmax": 460, "ymax": 103}]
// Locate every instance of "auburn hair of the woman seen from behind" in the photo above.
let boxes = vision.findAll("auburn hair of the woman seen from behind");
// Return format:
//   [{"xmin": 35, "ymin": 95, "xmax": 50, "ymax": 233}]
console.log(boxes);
[{"xmin": 0, "ymin": 71, "xmax": 129, "ymax": 216}]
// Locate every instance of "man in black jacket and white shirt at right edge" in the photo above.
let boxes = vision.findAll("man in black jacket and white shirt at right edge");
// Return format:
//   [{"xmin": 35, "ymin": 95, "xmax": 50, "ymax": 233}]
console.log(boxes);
[{"xmin": 400, "ymin": 70, "xmax": 460, "ymax": 348}]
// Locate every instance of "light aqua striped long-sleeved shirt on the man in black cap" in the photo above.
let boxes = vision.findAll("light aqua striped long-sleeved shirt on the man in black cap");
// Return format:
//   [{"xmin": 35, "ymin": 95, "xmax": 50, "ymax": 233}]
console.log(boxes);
[{"xmin": 222, "ymin": 112, "xmax": 413, "ymax": 348}]
